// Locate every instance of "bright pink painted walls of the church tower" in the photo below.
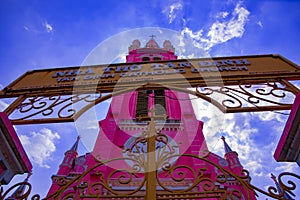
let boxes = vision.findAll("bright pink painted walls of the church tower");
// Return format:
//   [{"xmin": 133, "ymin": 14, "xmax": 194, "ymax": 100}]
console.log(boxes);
[{"xmin": 49, "ymin": 39, "xmax": 255, "ymax": 199}]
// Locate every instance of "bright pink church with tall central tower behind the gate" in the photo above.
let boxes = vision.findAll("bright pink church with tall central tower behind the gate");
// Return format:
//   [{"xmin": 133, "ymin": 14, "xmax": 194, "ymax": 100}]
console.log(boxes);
[{"xmin": 47, "ymin": 37, "xmax": 256, "ymax": 199}]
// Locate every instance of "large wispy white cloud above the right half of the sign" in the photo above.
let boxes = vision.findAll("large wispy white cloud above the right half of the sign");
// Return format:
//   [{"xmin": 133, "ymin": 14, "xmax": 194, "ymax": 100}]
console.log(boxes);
[{"xmin": 181, "ymin": 3, "xmax": 250, "ymax": 50}]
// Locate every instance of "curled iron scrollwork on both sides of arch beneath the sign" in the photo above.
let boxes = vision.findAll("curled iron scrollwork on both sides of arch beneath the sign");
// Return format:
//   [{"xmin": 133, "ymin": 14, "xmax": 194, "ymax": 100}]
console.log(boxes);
[{"xmin": 5, "ymin": 80, "xmax": 299, "ymax": 124}]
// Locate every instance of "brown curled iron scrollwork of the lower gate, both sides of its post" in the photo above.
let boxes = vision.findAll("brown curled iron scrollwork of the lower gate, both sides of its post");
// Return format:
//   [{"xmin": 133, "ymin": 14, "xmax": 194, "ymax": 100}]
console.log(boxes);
[{"xmin": 0, "ymin": 132, "xmax": 300, "ymax": 200}]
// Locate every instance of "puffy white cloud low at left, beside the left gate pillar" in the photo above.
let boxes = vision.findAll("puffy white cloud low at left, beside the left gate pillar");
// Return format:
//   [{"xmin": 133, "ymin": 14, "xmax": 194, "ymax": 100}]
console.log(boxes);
[{"xmin": 20, "ymin": 128, "xmax": 60, "ymax": 168}]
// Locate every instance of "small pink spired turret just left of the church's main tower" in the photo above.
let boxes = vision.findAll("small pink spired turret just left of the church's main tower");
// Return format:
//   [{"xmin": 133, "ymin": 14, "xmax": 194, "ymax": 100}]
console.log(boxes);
[{"xmin": 57, "ymin": 136, "xmax": 80, "ymax": 176}]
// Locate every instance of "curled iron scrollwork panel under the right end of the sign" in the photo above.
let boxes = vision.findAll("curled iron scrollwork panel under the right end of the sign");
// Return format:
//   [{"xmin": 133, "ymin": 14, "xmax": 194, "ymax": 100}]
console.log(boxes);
[{"xmin": 195, "ymin": 82, "xmax": 296, "ymax": 112}]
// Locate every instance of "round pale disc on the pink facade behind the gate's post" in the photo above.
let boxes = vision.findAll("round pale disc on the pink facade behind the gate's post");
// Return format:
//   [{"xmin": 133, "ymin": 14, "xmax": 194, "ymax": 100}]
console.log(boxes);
[{"xmin": 123, "ymin": 134, "xmax": 179, "ymax": 171}]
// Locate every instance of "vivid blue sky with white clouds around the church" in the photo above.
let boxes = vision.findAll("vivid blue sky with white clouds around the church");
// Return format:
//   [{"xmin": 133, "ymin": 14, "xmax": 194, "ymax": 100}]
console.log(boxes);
[{"xmin": 0, "ymin": 0, "xmax": 300, "ymax": 198}]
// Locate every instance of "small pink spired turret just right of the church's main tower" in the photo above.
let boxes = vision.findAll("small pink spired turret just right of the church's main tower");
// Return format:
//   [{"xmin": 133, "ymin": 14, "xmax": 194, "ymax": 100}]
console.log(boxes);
[{"xmin": 221, "ymin": 136, "xmax": 243, "ymax": 174}]
